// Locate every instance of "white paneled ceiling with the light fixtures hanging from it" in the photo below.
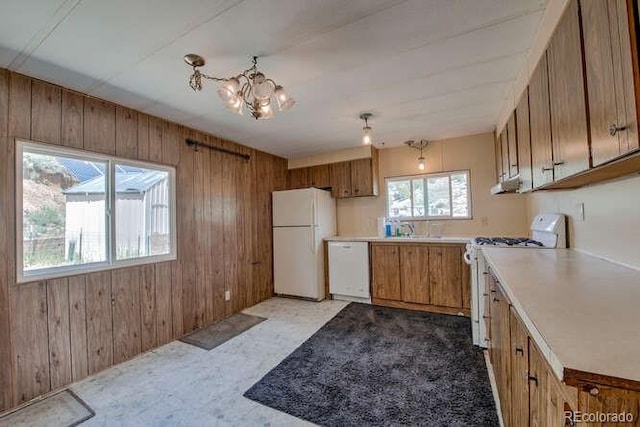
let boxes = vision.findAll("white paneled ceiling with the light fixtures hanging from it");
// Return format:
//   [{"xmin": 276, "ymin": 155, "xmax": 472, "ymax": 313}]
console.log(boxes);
[{"xmin": 0, "ymin": 0, "xmax": 546, "ymax": 158}]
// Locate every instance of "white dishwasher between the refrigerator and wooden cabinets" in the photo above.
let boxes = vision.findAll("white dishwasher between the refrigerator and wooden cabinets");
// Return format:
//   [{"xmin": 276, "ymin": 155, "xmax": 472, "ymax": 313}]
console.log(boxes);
[{"xmin": 329, "ymin": 242, "xmax": 371, "ymax": 303}]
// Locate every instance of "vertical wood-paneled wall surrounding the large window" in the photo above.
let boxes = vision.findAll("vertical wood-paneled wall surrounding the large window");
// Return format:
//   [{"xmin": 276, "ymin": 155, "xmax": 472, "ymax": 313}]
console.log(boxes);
[{"xmin": 0, "ymin": 69, "xmax": 287, "ymax": 411}]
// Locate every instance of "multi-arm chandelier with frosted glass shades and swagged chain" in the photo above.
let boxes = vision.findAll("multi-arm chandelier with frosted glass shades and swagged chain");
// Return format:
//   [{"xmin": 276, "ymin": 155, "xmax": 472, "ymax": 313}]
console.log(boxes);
[{"xmin": 184, "ymin": 53, "xmax": 296, "ymax": 120}]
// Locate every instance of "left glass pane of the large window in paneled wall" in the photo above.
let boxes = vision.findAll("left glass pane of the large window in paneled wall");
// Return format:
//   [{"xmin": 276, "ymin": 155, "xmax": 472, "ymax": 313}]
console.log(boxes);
[{"xmin": 22, "ymin": 152, "xmax": 107, "ymax": 271}]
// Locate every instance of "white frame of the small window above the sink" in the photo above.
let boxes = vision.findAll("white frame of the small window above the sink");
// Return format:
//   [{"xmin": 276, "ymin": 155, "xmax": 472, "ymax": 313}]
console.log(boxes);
[{"xmin": 384, "ymin": 169, "xmax": 473, "ymax": 221}]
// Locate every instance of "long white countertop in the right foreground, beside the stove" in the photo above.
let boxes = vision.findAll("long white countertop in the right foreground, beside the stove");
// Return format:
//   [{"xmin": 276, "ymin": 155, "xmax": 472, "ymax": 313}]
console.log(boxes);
[{"xmin": 482, "ymin": 247, "xmax": 640, "ymax": 381}]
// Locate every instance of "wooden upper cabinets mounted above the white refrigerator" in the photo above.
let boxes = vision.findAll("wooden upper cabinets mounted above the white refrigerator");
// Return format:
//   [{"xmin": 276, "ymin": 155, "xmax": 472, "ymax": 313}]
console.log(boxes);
[{"xmin": 288, "ymin": 147, "xmax": 378, "ymax": 199}]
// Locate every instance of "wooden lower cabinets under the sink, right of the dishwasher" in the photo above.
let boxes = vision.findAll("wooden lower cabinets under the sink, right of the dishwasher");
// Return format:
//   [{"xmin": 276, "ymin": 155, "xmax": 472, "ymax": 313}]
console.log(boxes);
[{"xmin": 371, "ymin": 242, "xmax": 471, "ymax": 316}]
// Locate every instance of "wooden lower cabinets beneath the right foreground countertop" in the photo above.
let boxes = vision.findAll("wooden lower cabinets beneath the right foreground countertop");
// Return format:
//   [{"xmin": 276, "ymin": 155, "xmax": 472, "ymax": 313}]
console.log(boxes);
[{"xmin": 485, "ymin": 273, "xmax": 640, "ymax": 427}]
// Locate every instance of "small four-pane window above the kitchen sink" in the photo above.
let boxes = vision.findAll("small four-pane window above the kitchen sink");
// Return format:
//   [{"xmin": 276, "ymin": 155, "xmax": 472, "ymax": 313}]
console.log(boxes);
[{"xmin": 386, "ymin": 171, "xmax": 471, "ymax": 219}]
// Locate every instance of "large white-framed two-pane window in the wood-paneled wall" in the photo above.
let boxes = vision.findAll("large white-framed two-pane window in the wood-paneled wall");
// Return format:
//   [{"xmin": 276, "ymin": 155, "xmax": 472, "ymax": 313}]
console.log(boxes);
[{"xmin": 16, "ymin": 141, "xmax": 175, "ymax": 282}]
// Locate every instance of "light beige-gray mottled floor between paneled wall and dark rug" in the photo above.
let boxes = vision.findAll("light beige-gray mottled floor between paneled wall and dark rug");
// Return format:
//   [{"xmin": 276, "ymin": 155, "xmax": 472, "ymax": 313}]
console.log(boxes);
[{"xmin": 7, "ymin": 298, "xmax": 347, "ymax": 426}]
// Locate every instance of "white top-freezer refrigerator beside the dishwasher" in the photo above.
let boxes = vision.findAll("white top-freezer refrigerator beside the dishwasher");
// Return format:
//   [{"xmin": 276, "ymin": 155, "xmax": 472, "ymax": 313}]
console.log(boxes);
[{"xmin": 273, "ymin": 188, "xmax": 336, "ymax": 301}]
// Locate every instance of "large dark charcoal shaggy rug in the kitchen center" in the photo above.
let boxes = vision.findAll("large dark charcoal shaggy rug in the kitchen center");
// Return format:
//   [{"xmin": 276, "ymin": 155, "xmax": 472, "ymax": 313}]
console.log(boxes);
[{"xmin": 244, "ymin": 303, "xmax": 499, "ymax": 427}]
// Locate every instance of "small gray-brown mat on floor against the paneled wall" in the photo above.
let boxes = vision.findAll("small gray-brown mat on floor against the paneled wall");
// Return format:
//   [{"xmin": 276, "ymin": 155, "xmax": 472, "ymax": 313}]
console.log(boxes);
[{"xmin": 180, "ymin": 313, "xmax": 267, "ymax": 350}]
